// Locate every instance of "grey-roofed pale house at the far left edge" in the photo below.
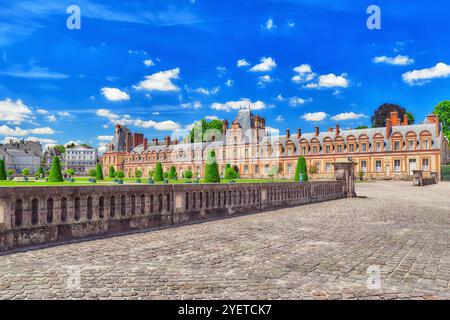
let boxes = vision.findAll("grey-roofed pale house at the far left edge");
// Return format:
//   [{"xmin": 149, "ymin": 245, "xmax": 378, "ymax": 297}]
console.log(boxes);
[{"xmin": 0, "ymin": 142, "xmax": 42, "ymax": 173}]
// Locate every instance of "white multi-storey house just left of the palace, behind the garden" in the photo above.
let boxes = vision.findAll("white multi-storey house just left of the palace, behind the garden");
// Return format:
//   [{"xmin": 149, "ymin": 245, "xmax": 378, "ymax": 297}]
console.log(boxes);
[{"xmin": 64, "ymin": 146, "xmax": 98, "ymax": 175}]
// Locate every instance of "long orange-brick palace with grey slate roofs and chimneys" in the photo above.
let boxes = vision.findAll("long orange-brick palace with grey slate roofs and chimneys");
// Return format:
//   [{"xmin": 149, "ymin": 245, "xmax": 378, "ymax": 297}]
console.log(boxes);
[{"xmin": 102, "ymin": 109, "xmax": 449, "ymax": 179}]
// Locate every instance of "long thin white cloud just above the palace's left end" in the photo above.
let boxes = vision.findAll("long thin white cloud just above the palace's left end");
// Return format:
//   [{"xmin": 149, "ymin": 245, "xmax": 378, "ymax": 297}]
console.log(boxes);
[{"xmin": 96, "ymin": 109, "xmax": 180, "ymax": 131}]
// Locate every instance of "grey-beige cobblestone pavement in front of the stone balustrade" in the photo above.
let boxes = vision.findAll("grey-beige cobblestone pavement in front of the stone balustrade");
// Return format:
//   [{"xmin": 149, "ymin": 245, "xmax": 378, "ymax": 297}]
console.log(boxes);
[{"xmin": 0, "ymin": 182, "xmax": 450, "ymax": 299}]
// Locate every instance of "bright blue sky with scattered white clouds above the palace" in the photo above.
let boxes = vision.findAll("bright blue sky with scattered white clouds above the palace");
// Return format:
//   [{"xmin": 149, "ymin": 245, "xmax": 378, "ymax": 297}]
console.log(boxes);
[{"xmin": 0, "ymin": 0, "xmax": 450, "ymax": 152}]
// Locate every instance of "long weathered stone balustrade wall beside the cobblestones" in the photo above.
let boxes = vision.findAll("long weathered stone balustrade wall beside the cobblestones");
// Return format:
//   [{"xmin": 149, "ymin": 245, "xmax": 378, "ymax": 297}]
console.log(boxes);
[{"xmin": 0, "ymin": 164, "xmax": 354, "ymax": 251}]
